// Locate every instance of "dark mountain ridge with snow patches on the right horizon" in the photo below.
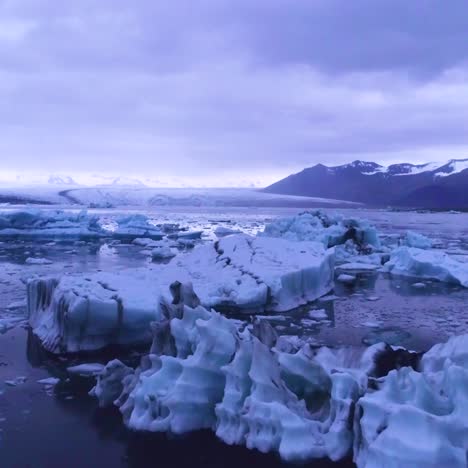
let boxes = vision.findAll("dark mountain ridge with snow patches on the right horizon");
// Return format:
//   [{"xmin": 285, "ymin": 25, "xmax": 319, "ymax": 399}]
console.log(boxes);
[{"xmin": 264, "ymin": 159, "xmax": 468, "ymax": 209}]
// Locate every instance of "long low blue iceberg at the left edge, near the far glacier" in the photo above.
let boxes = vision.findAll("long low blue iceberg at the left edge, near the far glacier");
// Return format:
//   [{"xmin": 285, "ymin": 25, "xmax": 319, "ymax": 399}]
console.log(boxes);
[{"xmin": 0, "ymin": 209, "xmax": 105, "ymax": 239}]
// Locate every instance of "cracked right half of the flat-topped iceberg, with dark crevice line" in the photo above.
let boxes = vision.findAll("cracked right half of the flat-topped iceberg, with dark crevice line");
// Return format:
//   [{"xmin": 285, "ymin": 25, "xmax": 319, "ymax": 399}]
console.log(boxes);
[{"xmin": 171, "ymin": 234, "xmax": 334, "ymax": 312}]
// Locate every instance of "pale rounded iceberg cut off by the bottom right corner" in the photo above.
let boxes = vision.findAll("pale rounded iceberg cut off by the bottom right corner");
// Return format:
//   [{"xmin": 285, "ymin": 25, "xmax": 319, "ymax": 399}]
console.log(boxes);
[{"xmin": 354, "ymin": 335, "xmax": 468, "ymax": 468}]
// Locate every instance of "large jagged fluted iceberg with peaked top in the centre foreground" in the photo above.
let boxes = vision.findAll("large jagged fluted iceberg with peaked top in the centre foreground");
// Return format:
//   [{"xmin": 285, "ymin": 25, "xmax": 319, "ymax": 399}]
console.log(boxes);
[{"xmin": 91, "ymin": 294, "xmax": 393, "ymax": 462}]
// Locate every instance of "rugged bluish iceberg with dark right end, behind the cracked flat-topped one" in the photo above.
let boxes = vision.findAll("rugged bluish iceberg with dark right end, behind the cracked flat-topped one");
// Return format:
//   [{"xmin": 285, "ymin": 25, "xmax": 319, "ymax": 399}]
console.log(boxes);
[{"xmin": 259, "ymin": 211, "xmax": 380, "ymax": 251}]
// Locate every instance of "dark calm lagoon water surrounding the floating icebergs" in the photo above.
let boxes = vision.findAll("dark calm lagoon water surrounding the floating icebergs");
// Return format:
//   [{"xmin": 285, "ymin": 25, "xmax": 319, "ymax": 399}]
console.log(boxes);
[{"xmin": 0, "ymin": 210, "xmax": 468, "ymax": 468}]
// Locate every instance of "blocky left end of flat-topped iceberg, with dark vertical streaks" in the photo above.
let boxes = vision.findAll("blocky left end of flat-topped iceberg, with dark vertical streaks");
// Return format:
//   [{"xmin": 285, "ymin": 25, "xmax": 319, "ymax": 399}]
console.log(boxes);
[{"xmin": 27, "ymin": 271, "xmax": 166, "ymax": 353}]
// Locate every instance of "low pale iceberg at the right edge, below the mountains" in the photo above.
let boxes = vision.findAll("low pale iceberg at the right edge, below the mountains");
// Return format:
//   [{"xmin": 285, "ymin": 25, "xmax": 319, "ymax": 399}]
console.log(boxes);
[{"xmin": 384, "ymin": 247, "xmax": 468, "ymax": 288}]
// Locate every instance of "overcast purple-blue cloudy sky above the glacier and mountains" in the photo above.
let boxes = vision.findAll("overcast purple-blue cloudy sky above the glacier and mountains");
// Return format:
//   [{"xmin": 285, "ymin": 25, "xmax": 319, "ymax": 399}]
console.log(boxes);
[{"xmin": 0, "ymin": 0, "xmax": 468, "ymax": 185}]
